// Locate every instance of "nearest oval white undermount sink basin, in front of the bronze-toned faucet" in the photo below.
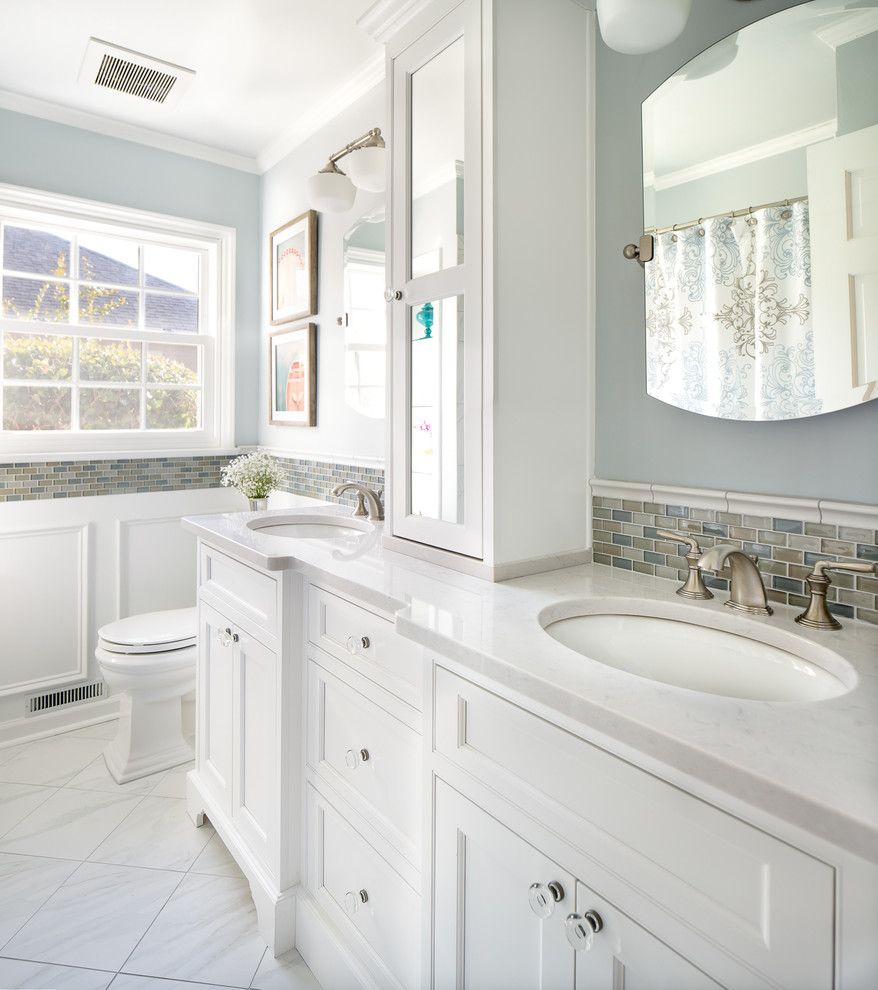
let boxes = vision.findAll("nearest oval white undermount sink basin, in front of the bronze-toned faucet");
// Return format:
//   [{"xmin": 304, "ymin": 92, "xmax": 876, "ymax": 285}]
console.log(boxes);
[{"xmin": 540, "ymin": 605, "xmax": 856, "ymax": 702}]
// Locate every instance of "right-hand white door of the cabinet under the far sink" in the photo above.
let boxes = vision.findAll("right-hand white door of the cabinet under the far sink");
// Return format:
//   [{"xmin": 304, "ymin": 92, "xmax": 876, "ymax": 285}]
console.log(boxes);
[{"xmin": 232, "ymin": 631, "xmax": 280, "ymax": 865}]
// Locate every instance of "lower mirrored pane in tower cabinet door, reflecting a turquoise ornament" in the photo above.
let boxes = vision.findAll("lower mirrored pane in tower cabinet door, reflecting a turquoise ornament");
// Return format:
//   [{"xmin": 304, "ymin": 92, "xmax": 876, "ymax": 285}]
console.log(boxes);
[{"xmin": 411, "ymin": 296, "xmax": 464, "ymax": 523}]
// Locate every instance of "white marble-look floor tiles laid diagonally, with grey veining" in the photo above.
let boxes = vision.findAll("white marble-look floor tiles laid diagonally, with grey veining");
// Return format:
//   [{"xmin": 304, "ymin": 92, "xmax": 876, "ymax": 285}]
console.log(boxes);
[{"xmin": 0, "ymin": 722, "xmax": 320, "ymax": 990}]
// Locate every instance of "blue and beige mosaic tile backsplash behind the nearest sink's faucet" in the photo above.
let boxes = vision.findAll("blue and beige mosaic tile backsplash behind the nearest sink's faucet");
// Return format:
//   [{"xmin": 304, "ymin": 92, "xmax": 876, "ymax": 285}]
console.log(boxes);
[{"xmin": 593, "ymin": 496, "xmax": 878, "ymax": 624}]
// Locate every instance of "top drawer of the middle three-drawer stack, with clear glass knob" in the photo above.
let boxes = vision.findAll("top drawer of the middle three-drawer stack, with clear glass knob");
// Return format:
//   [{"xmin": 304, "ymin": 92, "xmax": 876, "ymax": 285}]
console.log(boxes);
[{"xmin": 308, "ymin": 586, "xmax": 423, "ymax": 709}]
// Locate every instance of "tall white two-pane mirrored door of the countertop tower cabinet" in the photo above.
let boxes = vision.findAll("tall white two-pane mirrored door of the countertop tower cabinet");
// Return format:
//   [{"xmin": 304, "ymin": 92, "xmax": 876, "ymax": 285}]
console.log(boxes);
[{"xmin": 389, "ymin": 0, "xmax": 482, "ymax": 557}]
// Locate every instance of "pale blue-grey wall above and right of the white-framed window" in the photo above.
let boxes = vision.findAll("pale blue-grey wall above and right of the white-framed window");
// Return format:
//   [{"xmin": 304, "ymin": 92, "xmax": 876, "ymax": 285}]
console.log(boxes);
[{"xmin": 0, "ymin": 110, "xmax": 260, "ymax": 443}]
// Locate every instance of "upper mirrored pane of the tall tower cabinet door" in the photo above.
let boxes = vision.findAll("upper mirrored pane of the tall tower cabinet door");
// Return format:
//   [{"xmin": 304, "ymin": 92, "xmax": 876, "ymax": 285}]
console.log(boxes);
[{"xmin": 411, "ymin": 38, "xmax": 464, "ymax": 278}]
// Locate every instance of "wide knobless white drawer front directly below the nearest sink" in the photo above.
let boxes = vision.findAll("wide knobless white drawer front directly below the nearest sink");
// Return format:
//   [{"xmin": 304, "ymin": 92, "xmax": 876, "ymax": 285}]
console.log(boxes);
[{"xmin": 435, "ymin": 667, "xmax": 835, "ymax": 990}]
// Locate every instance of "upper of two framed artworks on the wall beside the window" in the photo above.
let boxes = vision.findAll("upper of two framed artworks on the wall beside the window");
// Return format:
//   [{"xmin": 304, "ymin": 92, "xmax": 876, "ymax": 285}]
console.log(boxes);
[{"xmin": 268, "ymin": 210, "xmax": 317, "ymax": 326}]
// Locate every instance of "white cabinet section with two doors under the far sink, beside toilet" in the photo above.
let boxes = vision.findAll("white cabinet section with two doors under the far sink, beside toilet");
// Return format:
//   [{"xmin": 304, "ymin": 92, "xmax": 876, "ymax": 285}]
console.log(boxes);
[{"xmin": 188, "ymin": 543, "xmax": 302, "ymax": 953}]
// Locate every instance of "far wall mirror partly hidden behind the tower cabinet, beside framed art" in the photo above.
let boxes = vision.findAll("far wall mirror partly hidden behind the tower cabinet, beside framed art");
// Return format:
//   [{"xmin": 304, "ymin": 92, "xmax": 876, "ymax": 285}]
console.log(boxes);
[{"xmin": 343, "ymin": 206, "xmax": 387, "ymax": 419}]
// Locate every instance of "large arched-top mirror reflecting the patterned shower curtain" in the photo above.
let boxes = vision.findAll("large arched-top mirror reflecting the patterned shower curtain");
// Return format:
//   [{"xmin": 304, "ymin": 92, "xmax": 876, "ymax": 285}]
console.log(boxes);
[{"xmin": 643, "ymin": 0, "xmax": 878, "ymax": 420}]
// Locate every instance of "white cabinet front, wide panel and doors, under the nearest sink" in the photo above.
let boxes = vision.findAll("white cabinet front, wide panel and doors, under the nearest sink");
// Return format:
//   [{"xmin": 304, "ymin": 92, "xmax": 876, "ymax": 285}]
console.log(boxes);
[{"xmin": 433, "ymin": 664, "xmax": 837, "ymax": 990}]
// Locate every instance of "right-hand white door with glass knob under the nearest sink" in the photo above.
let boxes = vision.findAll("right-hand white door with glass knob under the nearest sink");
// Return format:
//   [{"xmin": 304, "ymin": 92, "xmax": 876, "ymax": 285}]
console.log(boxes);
[{"xmin": 576, "ymin": 883, "xmax": 720, "ymax": 990}]
